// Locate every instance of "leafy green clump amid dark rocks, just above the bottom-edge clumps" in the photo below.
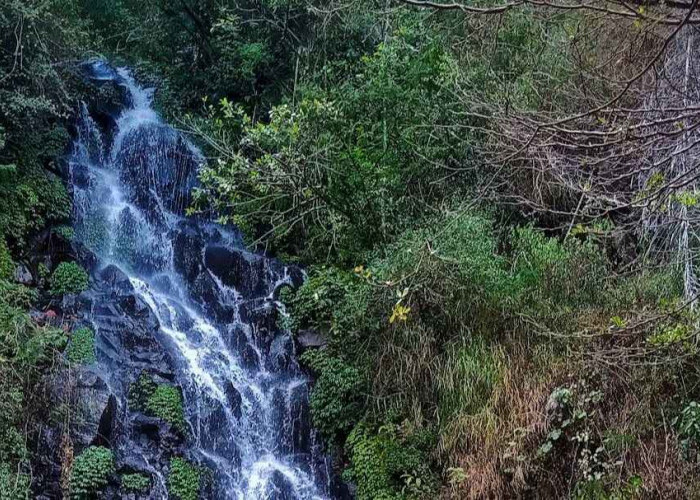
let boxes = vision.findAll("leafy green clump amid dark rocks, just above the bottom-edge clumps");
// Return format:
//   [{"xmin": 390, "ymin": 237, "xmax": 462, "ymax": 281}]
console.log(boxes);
[{"xmin": 129, "ymin": 372, "xmax": 186, "ymax": 432}]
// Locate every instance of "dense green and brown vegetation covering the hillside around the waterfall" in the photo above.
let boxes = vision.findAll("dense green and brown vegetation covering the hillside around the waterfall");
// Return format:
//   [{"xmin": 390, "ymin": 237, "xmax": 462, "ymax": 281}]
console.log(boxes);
[{"xmin": 0, "ymin": 0, "xmax": 700, "ymax": 500}]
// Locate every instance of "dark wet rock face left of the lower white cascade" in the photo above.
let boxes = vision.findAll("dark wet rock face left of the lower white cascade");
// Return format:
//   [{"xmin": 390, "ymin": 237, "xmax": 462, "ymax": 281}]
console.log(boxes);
[{"xmin": 35, "ymin": 256, "xmax": 186, "ymax": 499}]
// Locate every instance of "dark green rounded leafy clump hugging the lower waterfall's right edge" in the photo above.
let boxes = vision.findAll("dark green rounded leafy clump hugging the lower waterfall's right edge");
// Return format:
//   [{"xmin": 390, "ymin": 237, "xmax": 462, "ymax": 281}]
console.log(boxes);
[{"xmin": 301, "ymin": 350, "xmax": 364, "ymax": 441}]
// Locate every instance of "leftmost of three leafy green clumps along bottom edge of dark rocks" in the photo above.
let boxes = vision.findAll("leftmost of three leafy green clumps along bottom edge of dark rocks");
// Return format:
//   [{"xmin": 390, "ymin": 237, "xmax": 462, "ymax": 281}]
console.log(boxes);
[{"xmin": 70, "ymin": 446, "xmax": 115, "ymax": 500}]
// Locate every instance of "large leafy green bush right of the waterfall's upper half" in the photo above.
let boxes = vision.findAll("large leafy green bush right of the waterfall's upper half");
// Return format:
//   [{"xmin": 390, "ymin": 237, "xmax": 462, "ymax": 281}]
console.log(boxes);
[{"xmin": 196, "ymin": 26, "xmax": 464, "ymax": 260}]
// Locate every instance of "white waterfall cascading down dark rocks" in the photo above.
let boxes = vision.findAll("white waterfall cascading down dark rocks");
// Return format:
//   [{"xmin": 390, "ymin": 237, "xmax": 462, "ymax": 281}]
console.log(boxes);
[{"xmin": 70, "ymin": 63, "xmax": 330, "ymax": 499}]
